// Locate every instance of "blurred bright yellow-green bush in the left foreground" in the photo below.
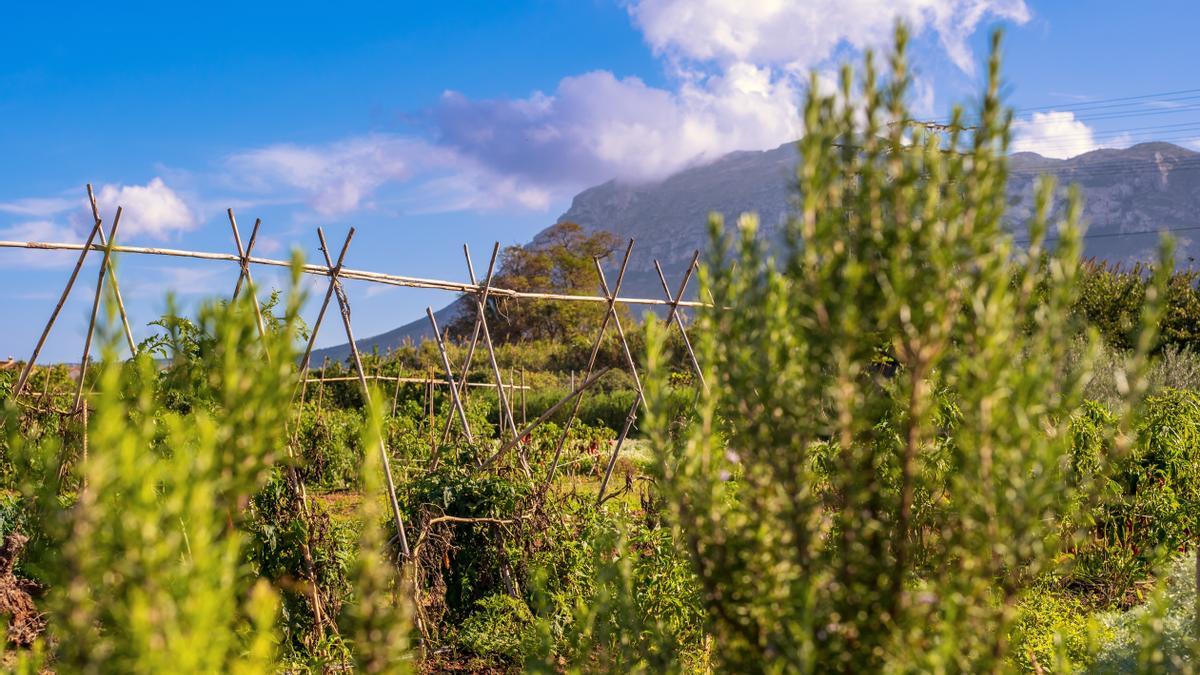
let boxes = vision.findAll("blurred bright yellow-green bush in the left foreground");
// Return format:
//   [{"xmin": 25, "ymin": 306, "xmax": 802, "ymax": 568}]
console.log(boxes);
[{"xmin": 35, "ymin": 269, "xmax": 299, "ymax": 673}]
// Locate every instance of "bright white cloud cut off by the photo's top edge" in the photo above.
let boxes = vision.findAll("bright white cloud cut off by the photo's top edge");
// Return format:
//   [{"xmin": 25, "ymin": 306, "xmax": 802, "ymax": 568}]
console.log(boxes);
[{"xmin": 629, "ymin": 0, "xmax": 1030, "ymax": 72}]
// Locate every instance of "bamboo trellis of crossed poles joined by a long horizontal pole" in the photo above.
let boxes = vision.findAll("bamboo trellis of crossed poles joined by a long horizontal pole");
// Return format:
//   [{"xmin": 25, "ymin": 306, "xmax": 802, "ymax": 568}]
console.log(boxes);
[{"xmin": 0, "ymin": 184, "xmax": 707, "ymax": 632}]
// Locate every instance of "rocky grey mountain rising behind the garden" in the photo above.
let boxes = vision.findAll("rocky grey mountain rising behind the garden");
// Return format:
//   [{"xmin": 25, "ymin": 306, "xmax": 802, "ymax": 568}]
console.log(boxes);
[{"xmin": 317, "ymin": 143, "xmax": 1200, "ymax": 362}]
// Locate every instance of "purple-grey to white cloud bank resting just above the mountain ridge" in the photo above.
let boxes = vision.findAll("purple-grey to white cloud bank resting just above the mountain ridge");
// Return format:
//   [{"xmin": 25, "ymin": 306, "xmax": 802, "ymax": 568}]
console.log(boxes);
[{"xmin": 436, "ymin": 65, "xmax": 800, "ymax": 185}]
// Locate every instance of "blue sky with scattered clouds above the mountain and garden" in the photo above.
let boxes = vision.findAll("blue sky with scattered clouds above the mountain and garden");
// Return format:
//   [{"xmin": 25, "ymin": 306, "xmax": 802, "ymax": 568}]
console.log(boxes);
[{"xmin": 0, "ymin": 0, "xmax": 1200, "ymax": 360}]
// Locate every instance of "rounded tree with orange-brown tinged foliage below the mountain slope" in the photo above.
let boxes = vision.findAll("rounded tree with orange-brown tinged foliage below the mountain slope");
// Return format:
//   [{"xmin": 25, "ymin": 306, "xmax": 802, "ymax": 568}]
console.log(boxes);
[{"xmin": 450, "ymin": 222, "xmax": 618, "ymax": 342}]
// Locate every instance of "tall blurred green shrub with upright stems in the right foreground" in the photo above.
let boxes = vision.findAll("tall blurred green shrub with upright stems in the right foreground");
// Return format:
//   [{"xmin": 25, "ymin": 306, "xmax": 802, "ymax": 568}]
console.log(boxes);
[{"xmin": 646, "ymin": 26, "xmax": 1165, "ymax": 671}]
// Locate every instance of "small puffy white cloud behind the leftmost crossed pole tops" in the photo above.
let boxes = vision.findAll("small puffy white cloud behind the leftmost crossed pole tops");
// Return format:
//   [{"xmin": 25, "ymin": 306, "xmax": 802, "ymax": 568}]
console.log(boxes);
[{"xmin": 92, "ymin": 178, "xmax": 196, "ymax": 239}]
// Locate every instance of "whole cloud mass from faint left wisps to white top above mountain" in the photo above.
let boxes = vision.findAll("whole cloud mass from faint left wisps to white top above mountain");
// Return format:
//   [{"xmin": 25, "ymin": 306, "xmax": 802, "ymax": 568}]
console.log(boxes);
[{"xmin": 216, "ymin": 0, "xmax": 1030, "ymax": 215}]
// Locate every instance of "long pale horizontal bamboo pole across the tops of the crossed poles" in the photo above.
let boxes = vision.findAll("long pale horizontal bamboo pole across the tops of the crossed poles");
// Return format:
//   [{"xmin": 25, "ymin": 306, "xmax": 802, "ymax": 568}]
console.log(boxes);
[{"xmin": 0, "ymin": 240, "xmax": 709, "ymax": 307}]
